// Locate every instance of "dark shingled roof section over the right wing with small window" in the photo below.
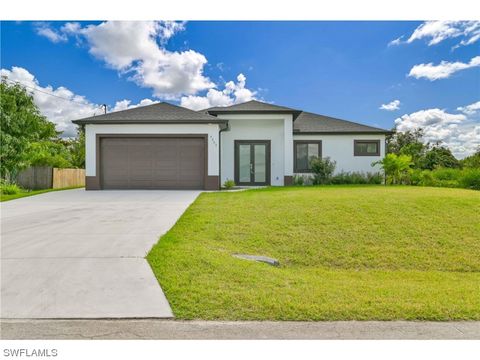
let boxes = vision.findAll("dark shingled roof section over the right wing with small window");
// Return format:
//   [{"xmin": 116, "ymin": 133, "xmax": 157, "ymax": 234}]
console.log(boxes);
[{"xmin": 293, "ymin": 112, "xmax": 390, "ymax": 134}]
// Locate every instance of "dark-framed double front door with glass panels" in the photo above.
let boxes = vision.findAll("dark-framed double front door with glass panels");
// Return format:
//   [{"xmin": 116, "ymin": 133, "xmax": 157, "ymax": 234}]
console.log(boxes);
[{"xmin": 235, "ymin": 140, "xmax": 270, "ymax": 186}]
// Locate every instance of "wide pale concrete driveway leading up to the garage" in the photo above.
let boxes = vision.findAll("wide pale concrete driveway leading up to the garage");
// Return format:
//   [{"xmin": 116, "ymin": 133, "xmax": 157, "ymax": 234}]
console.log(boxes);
[{"xmin": 1, "ymin": 189, "xmax": 200, "ymax": 318}]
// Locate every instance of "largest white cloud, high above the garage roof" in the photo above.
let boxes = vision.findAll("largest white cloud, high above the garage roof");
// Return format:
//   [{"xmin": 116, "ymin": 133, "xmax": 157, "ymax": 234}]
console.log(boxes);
[{"xmin": 67, "ymin": 21, "xmax": 215, "ymax": 99}]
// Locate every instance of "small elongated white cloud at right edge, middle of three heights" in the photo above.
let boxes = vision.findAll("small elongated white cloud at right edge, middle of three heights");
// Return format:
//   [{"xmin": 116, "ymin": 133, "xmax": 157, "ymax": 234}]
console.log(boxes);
[{"xmin": 408, "ymin": 56, "xmax": 480, "ymax": 81}]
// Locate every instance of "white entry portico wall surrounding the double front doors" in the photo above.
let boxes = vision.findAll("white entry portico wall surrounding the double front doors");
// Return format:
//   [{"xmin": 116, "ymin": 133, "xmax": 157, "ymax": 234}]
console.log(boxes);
[{"xmin": 218, "ymin": 114, "xmax": 293, "ymax": 186}]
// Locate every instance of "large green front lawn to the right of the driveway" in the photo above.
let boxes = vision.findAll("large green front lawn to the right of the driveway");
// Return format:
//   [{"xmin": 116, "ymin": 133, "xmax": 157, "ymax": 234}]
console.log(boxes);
[{"xmin": 147, "ymin": 186, "xmax": 480, "ymax": 320}]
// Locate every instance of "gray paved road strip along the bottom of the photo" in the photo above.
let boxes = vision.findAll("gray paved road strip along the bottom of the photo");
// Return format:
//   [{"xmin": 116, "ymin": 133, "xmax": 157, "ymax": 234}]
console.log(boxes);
[{"xmin": 0, "ymin": 320, "xmax": 480, "ymax": 340}]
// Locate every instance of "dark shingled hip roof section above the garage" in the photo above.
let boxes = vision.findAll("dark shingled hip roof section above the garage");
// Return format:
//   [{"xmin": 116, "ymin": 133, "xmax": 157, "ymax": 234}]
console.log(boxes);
[{"xmin": 73, "ymin": 102, "xmax": 226, "ymax": 124}]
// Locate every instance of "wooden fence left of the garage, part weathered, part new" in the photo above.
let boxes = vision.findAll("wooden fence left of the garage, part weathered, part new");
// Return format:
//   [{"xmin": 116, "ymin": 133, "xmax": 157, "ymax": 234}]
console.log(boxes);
[{"xmin": 17, "ymin": 166, "xmax": 85, "ymax": 190}]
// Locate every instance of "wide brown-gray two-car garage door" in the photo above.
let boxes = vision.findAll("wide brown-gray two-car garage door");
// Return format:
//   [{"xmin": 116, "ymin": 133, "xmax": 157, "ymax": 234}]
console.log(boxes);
[{"xmin": 100, "ymin": 137, "xmax": 205, "ymax": 189}]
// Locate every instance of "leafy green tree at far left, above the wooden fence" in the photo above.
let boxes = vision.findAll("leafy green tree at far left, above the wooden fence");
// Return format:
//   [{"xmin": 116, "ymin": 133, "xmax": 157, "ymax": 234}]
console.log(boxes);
[{"xmin": 0, "ymin": 79, "xmax": 58, "ymax": 180}]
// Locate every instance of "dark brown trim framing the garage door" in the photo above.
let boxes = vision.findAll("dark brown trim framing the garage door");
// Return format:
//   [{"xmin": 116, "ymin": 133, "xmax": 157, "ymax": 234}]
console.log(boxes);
[{"xmin": 95, "ymin": 134, "xmax": 209, "ymax": 190}]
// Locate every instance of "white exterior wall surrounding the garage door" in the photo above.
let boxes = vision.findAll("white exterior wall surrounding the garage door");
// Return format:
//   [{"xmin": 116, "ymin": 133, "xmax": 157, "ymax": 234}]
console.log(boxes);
[{"xmin": 85, "ymin": 124, "xmax": 220, "ymax": 189}]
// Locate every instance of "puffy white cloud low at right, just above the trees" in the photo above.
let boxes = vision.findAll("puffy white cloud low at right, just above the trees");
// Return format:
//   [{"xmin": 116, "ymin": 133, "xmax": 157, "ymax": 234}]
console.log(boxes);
[{"xmin": 395, "ymin": 109, "xmax": 480, "ymax": 158}]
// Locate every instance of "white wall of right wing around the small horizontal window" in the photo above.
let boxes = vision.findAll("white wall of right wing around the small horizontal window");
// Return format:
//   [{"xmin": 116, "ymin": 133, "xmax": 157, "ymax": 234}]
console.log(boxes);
[{"xmin": 293, "ymin": 134, "xmax": 385, "ymax": 173}]
